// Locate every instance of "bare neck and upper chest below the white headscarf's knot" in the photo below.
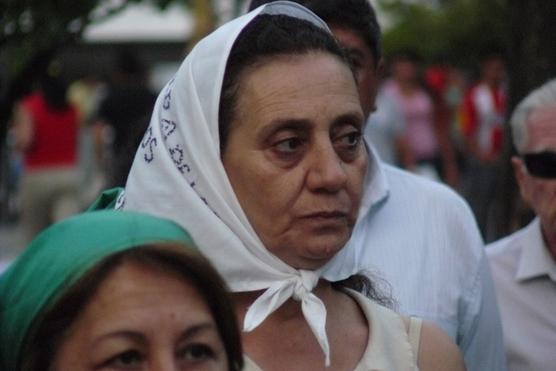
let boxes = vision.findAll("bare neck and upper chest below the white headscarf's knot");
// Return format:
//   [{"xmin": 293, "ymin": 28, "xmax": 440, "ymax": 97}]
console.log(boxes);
[{"xmin": 233, "ymin": 280, "xmax": 369, "ymax": 371}]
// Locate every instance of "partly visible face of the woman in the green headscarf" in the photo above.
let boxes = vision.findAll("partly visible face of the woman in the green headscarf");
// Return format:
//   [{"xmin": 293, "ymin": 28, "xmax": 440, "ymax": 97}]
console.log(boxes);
[{"xmin": 53, "ymin": 264, "xmax": 228, "ymax": 371}]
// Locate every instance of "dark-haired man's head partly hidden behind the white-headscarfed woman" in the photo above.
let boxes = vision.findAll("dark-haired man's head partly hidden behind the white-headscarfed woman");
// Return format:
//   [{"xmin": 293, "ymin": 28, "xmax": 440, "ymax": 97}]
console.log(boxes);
[{"xmin": 249, "ymin": 0, "xmax": 382, "ymax": 116}]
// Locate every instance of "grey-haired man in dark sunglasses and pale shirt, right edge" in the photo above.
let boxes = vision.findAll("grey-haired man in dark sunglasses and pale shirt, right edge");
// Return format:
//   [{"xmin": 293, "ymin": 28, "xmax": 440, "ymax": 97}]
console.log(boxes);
[{"xmin": 487, "ymin": 79, "xmax": 556, "ymax": 371}]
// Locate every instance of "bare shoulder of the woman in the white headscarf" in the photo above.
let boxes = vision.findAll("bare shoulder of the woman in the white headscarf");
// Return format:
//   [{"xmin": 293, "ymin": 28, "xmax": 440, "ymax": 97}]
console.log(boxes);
[{"xmin": 417, "ymin": 321, "xmax": 465, "ymax": 371}]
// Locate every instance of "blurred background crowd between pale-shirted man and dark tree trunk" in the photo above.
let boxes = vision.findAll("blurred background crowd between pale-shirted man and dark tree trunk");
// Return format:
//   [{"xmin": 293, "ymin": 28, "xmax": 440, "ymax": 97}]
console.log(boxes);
[{"xmin": 366, "ymin": 50, "xmax": 508, "ymax": 237}]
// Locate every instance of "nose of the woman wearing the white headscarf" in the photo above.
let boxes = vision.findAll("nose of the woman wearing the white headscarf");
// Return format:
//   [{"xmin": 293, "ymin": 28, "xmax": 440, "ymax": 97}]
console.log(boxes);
[{"xmin": 307, "ymin": 142, "xmax": 348, "ymax": 192}]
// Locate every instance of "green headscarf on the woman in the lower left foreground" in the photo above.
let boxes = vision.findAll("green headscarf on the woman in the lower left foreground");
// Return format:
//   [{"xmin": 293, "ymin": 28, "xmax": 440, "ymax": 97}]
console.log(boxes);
[{"xmin": 0, "ymin": 211, "xmax": 193, "ymax": 371}]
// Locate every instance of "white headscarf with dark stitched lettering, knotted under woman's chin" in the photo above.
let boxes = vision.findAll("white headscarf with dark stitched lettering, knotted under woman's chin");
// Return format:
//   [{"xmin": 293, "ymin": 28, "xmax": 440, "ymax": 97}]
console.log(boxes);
[{"xmin": 122, "ymin": 1, "xmax": 373, "ymax": 365}]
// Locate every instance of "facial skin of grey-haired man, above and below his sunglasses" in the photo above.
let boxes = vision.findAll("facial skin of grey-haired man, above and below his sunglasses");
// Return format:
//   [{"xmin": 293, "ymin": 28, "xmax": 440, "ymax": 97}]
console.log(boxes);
[{"xmin": 512, "ymin": 103, "xmax": 556, "ymax": 260}]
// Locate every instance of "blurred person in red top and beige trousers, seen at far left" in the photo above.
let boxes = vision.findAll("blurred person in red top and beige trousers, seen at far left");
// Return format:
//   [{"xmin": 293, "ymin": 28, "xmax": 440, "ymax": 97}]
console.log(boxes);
[{"xmin": 13, "ymin": 76, "xmax": 79, "ymax": 240}]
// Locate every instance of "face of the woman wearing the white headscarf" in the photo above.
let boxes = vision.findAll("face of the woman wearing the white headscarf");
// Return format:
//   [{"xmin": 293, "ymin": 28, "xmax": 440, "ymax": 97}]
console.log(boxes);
[{"xmin": 223, "ymin": 52, "xmax": 367, "ymax": 269}]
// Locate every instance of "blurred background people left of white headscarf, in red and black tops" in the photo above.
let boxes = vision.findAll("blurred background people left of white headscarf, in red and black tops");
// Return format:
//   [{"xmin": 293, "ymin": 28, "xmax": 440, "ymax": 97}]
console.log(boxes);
[{"xmin": 6, "ymin": 49, "xmax": 156, "ymax": 247}]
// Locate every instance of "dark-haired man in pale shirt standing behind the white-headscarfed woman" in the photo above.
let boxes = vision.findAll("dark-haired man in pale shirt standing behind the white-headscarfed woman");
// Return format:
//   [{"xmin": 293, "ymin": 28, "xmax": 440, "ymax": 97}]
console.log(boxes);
[{"xmin": 245, "ymin": 0, "xmax": 506, "ymax": 371}]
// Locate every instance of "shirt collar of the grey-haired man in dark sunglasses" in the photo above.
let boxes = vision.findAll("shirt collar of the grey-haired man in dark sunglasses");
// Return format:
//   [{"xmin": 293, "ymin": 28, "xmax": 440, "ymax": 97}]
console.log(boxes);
[{"xmin": 515, "ymin": 217, "xmax": 556, "ymax": 282}]
